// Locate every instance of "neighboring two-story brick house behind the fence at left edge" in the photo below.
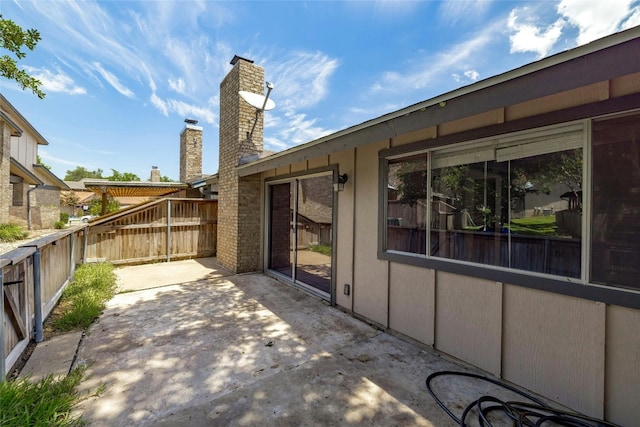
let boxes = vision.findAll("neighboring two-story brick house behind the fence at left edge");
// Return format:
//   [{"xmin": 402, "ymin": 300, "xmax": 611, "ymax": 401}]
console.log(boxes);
[{"xmin": 0, "ymin": 94, "xmax": 68, "ymax": 229}]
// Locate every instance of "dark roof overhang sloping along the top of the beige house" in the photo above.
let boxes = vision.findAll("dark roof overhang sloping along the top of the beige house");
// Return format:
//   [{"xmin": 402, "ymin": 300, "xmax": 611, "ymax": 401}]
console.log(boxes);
[{"xmin": 237, "ymin": 27, "xmax": 640, "ymax": 176}]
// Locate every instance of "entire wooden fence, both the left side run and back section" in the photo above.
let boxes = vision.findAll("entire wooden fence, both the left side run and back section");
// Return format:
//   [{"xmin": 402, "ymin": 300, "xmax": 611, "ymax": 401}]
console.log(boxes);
[{"xmin": 0, "ymin": 199, "xmax": 218, "ymax": 381}]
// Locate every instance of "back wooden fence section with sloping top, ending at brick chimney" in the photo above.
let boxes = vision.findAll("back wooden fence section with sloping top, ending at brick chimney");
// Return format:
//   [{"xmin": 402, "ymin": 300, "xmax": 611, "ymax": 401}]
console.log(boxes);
[{"xmin": 86, "ymin": 199, "xmax": 218, "ymax": 264}]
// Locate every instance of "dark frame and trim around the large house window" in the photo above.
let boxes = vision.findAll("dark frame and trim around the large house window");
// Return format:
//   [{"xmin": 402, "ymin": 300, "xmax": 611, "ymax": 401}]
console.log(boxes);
[{"xmin": 378, "ymin": 118, "xmax": 640, "ymax": 309}]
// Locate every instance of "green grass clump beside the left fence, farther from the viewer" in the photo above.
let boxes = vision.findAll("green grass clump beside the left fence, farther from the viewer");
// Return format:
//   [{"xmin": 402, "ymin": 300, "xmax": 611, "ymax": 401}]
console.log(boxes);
[{"xmin": 50, "ymin": 262, "xmax": 117, "ymax": 332}]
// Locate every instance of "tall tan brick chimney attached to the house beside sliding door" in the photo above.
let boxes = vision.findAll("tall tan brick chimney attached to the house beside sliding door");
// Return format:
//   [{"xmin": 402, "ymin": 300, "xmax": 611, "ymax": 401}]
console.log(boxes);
[{"xmin": 217, "ymin": 55, "xmax": 265, "ymax": 273}]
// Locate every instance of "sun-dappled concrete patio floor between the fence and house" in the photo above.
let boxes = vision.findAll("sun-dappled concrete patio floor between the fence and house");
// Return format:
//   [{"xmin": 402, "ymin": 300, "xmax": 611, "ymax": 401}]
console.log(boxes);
[{"xmin": 70, "ymin": 259, "xmax": 548, "ymax": 426}]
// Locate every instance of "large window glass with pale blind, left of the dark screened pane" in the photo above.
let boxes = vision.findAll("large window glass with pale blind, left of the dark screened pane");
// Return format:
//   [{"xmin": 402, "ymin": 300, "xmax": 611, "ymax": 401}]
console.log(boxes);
[{"xmin": 386, "ymin": 123, "xmax": 584, "ymax": 279}]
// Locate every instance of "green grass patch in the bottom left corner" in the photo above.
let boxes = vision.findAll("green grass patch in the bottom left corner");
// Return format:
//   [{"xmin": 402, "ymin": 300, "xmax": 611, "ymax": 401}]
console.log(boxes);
[{"xmin": 0, "ymin": 368, "xmax": 86, "ymax": 426}]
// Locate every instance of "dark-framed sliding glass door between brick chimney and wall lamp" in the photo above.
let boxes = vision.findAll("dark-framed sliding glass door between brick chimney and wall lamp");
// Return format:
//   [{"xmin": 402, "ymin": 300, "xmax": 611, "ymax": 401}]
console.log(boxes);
[{"xmin": 268, "ymin": 173, "xmax": 333, "ymax": 299}]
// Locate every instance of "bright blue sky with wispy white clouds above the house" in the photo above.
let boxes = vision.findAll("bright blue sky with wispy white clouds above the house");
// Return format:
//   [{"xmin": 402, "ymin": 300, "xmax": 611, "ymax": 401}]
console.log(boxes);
[{"xmin": 0, "ymin": 0, "xmax": 640, "ymax": 180}]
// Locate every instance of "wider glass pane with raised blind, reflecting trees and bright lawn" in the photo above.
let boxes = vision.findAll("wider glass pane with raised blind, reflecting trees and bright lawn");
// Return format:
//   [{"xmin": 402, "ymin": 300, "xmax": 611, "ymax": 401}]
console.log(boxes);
[{"xmin": 430, "ymin": 128, "xmax": 583, "ymax": 277}]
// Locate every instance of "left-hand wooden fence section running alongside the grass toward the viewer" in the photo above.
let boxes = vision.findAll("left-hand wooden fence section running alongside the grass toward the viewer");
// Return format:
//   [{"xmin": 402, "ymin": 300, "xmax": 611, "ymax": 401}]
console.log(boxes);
[{"xmin": 0, "ymin": 227, "xmax": 85, "ymax": 381}]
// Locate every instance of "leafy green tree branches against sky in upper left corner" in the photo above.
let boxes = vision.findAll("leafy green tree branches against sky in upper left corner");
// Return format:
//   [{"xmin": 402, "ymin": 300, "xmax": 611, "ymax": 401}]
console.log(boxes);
[{"xmin": 0, "ymin": 15, "xmax": 45, "ymax": 99}]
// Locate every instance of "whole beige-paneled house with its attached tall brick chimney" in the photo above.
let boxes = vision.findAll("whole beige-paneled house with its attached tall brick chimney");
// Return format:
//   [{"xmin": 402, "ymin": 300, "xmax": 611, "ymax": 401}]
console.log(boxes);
[{"xmin": 217, "ymin": 28, "xmax": 640, "ymax": 425}]
